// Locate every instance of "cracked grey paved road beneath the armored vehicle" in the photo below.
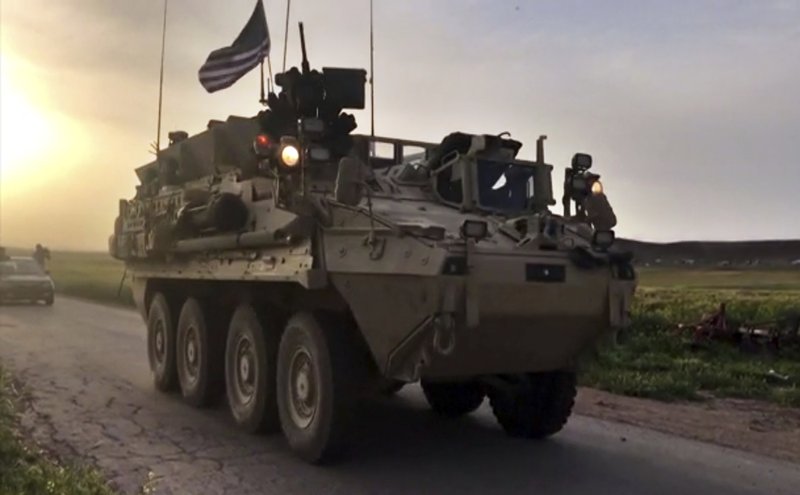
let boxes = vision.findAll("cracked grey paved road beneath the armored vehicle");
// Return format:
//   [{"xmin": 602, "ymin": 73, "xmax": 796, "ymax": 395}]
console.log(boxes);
[{"xmin": 0, "ymin": 298, "xmax": 800, "ymax": 495}]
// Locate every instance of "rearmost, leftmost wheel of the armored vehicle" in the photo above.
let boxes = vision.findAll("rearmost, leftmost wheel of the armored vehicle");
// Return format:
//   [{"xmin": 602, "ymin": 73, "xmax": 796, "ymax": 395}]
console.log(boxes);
[{"xmin": 147, "ymin": 292, "xmax": 178, "ymax": 392}]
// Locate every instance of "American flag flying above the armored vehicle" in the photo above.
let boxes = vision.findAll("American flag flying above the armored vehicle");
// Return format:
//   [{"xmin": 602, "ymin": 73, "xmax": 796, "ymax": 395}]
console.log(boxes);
[{"xmin": 198, "ymin": 0, "xmax": 270, "ymax": 93}]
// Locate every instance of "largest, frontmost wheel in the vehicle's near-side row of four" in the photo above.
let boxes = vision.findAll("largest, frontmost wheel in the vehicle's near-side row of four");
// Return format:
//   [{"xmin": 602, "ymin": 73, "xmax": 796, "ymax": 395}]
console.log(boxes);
[{"xmin": 278, "ymin": 313, "xmax": 363, "ymax": 464}]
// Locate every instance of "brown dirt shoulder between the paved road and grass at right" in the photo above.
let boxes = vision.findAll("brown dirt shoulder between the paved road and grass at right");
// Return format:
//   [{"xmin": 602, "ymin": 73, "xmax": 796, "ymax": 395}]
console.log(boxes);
[{"xmin": 575, "ymin": 388, "xmax": 800, "ymax": 464}]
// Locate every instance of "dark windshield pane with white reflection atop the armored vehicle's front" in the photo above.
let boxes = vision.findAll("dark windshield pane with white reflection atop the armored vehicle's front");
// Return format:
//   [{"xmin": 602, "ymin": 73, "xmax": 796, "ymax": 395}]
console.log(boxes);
[{"xmin": 478, "ymin": 160, "xmax": 533, "ymax": 211}]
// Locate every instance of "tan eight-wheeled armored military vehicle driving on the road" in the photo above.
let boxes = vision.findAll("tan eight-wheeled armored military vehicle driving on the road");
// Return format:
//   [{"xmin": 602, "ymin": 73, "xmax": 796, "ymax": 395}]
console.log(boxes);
[{"xmin": 109, "ymin": 33, "xmax": 636, "ymax": 462}]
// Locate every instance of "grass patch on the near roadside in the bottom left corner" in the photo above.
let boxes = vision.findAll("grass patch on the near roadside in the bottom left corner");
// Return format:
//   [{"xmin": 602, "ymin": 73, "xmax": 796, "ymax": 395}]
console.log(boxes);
[{"xmin": 0, "ymin": 367, "xmax": 114, "ymax": 495}]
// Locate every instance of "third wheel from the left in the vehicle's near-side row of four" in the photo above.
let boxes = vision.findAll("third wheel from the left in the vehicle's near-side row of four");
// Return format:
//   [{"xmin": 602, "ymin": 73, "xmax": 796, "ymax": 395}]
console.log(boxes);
[{"xmin": 225, "ymin": 303, "xmax": 279, "ymax": 433}]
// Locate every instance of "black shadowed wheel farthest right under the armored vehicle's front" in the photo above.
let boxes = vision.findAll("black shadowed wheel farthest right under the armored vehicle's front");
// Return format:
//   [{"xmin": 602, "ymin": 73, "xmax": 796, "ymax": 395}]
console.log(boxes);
[{"xmin": 489, "ymin": 371, "xmax": 576, "ymax": 438}]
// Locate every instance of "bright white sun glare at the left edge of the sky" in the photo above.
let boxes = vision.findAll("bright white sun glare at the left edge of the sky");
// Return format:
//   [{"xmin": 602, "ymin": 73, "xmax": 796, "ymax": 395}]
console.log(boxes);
[{"xmin": 0, "ymin": 55, "xmax": 56, "ymax": 182}]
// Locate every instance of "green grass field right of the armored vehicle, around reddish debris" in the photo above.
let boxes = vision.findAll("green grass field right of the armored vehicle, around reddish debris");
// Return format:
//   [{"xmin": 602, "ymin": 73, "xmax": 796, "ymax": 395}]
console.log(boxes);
[{"xmin": 581, "ymin": 287, "xmax": 800, "ymax": 407}]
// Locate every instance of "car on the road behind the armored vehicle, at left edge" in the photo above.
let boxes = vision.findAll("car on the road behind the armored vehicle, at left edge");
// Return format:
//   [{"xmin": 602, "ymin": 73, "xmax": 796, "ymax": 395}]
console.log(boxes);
[{"xmin": 0, "ymin": 256, "xmax": 55, "ymax": 306}]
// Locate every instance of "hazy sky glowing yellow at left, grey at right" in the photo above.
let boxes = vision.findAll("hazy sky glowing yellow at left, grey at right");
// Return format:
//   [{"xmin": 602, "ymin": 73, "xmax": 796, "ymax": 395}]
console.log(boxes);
[{"xmin": 0, "ymin": 0, "xmax": 800, "ymax": 249}]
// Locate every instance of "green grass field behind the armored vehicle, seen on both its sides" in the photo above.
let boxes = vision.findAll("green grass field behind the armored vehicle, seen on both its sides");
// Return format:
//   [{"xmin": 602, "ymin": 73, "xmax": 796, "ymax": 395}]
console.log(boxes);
[{"xmin": 9, "ymin": 251, "xmax": 800, "ymax": 406}]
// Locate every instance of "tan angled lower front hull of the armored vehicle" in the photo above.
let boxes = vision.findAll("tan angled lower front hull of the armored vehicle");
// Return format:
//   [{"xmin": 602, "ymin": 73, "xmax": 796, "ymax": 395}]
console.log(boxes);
[{"xmin": 333, "ymin": 253, "xmax": 635, "ymax": 380}]
